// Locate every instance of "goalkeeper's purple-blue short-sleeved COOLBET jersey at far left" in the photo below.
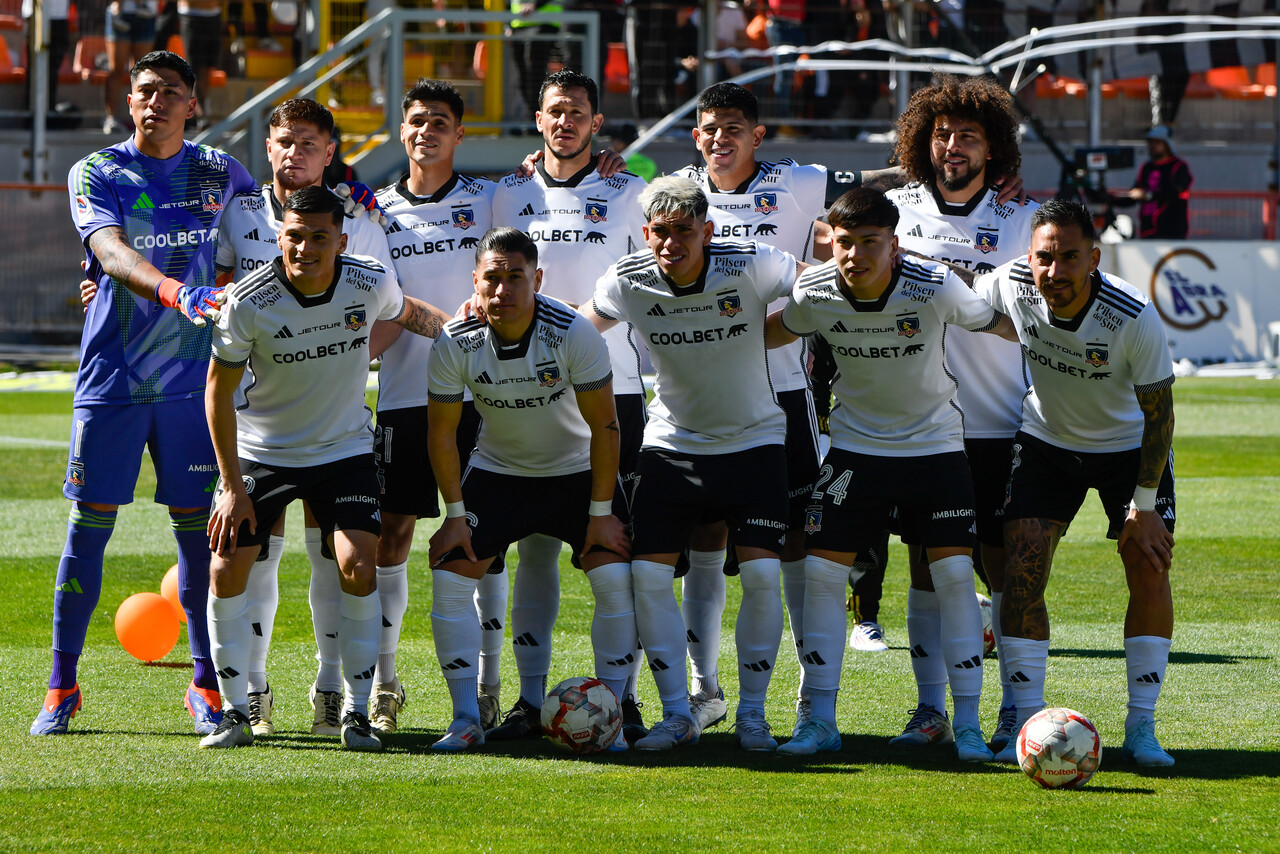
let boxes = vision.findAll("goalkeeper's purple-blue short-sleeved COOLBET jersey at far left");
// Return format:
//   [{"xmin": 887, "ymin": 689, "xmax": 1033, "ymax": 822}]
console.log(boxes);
[{"xmin": 67, "ymin": 137, "xmax": 256, "ymax": 406}]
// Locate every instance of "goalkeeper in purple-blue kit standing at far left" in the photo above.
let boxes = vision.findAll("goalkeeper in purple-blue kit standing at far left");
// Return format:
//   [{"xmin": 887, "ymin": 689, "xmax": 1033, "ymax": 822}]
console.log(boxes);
[{"xmin": 31, "ymin": 51, "xmax": 253, "ymax": 735}]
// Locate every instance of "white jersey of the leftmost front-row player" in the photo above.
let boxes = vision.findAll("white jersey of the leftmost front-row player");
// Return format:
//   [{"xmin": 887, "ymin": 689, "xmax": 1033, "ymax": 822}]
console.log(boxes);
[{"xmin": 214, "ymin": 255, "xmax": 404, "ymax": 466}]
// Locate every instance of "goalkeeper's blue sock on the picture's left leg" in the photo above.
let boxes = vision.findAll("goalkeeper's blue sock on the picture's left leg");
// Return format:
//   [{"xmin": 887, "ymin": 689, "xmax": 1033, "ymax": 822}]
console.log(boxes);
[{"xmin": 49, "ymin": 504, "xmax": 115, "ymax": 688}]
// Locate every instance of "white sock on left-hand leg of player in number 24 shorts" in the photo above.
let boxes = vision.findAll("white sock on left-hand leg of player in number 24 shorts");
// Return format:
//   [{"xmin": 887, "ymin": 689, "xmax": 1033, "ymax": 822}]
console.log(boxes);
[{"xmin": 783, "ymin": 554, "xmax": 850, "ymax": 723}]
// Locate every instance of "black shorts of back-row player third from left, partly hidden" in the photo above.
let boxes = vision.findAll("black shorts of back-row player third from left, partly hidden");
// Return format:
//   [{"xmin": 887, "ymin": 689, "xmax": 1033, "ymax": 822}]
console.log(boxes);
[{"xmin": 374, "ymin": 401, "xmax": 480, "ymax": 519}]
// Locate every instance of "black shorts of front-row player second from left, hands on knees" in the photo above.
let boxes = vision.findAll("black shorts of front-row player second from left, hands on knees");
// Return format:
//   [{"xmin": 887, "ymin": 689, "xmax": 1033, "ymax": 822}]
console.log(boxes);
[{"xmin": 440, "ymin": 466, "xmax": 627, "ymax": 567}]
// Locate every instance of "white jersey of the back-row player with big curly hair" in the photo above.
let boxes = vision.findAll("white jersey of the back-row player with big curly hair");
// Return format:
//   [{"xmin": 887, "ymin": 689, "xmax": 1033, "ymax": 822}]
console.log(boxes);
[{"xmin": 887, "ymin": 184, "xmax": 1039, "ymax": 439}]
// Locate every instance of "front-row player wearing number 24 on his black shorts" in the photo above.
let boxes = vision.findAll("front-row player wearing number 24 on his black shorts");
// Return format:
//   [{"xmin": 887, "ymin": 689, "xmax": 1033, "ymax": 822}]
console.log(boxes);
[{"xmin": 767, "ymin": 187, "xmax": 1014, "ymax": 762}]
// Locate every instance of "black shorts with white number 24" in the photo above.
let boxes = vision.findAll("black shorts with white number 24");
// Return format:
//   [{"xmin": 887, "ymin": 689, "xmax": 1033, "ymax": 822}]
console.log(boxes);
[{"xmin": 804, "ymin": 448, "xmax": 974, "ymax": 552}]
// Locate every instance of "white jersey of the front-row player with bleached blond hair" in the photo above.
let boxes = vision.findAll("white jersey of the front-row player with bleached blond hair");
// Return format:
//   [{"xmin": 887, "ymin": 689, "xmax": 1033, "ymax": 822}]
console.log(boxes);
[{"xmin": 590, "ymin": 241, "xmax": 796, "ymax": 453}]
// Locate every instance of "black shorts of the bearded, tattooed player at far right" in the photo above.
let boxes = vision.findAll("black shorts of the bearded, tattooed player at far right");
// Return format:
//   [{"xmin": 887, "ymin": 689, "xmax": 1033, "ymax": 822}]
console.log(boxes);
[{"xmin": 1005, "ymin": 431, "xmax": 1178, "ymax": 539}]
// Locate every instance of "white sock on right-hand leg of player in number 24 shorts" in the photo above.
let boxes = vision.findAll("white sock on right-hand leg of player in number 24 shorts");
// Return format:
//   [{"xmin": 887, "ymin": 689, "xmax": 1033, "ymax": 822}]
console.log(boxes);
[{"xmin": 929, "ymin": 554, "xmax": 982, "ymax": 727}]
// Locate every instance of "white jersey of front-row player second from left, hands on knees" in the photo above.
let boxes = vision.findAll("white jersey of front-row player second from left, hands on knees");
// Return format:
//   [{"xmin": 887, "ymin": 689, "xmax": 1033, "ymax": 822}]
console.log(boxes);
[{"xmin": 426, "ymin": 294, "xmax": 612, "ymax": 478}]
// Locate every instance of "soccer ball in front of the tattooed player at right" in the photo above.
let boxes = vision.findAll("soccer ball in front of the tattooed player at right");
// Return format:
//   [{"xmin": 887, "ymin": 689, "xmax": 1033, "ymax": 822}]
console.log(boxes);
[{"xmin": 1018, "ymin": 708, "xmax": 1102, "ymax": 789}]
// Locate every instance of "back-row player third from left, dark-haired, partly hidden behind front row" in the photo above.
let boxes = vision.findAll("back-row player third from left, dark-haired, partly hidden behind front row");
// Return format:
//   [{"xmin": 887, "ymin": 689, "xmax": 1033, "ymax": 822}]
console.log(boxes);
[{"xmin": 371, "ymin": 79, "xmax": 507, "ymax": 732}]
